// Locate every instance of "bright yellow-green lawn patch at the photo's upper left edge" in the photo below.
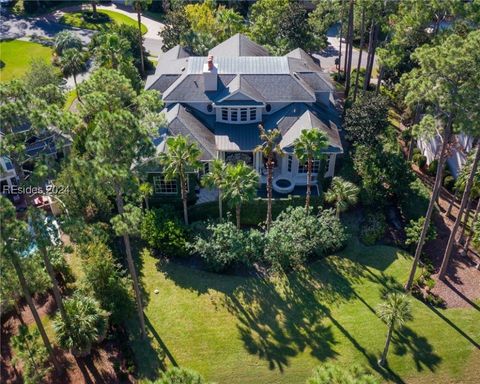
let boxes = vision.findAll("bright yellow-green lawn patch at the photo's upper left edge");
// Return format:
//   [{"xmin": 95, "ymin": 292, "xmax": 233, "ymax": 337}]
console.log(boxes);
[{"xmin": 0, "ymin": 40, "xmax": 52, "ymax": 82}]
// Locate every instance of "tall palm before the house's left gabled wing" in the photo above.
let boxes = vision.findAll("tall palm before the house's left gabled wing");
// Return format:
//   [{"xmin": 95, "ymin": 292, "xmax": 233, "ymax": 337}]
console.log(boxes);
[{"xmin": 160, "ymin": 135, "xmax": 201, "ymax": 224}]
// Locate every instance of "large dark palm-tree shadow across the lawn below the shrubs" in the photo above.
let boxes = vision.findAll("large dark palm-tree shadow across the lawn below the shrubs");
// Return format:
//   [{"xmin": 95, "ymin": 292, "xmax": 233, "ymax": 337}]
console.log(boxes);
[{"xmin": 158, "ymin": 257, "xmax": 364, "ymax": 371}]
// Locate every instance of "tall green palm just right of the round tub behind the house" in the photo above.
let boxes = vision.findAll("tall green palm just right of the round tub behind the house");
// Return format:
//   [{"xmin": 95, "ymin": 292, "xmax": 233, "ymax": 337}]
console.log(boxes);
[{"xmin": 293, "ymin": 128, "xmax": 328, "ymax": 214}]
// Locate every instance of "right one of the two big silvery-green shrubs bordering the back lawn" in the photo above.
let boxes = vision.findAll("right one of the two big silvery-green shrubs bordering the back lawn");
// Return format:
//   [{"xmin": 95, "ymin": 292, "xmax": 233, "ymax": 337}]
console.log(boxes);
[{"xmin": 265, "ymin": 207, "xmax": 346, "ymax": 269}]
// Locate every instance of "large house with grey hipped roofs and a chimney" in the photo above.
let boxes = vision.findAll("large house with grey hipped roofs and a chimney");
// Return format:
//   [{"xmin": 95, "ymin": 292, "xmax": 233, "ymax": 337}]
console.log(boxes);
[{"xmin": 146, "ymin": 34, "xmax": 343, "ymax": 200}]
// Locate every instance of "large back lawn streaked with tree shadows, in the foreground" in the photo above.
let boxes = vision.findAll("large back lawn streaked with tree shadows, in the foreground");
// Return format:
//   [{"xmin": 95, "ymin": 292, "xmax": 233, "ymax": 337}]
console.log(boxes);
[{"xmin": 132, "ymin": 218, "xmax": 480, "ymax": 384}]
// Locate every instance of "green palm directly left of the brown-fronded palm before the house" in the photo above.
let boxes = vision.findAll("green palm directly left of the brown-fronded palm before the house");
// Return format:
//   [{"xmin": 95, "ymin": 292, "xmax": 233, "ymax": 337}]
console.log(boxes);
[{"xmin": 224, "ymin": 161, "xmax": 258, "ymax": 229}]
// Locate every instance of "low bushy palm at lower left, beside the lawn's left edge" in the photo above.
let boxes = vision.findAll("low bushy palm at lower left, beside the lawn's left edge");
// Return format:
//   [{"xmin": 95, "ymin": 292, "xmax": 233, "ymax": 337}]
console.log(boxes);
[{"xmin": 53, "ymin": 292, "xmax": 108, "ymax": 357}]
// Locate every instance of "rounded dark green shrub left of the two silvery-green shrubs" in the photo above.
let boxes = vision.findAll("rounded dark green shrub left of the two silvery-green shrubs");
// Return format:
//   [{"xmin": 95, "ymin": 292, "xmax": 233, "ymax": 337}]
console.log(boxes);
[{"xmin": 140, "ymin": 208, "xmax": 187, "ymax": 257}]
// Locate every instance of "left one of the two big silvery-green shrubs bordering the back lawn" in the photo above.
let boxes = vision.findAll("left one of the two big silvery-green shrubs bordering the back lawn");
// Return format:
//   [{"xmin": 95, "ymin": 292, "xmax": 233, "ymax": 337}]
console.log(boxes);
[{"xmin": 190, "ymin": 221, "xmax": 263, "ymax": 272}]
